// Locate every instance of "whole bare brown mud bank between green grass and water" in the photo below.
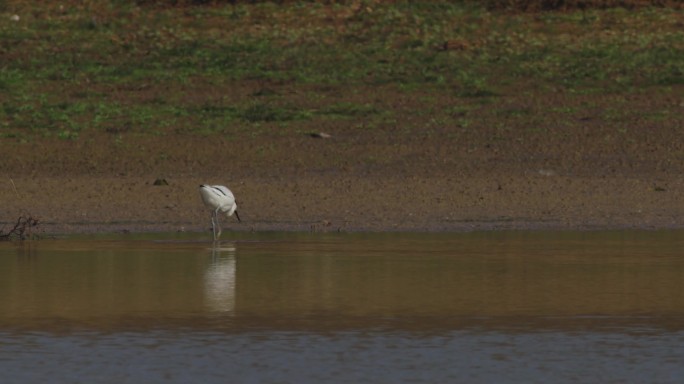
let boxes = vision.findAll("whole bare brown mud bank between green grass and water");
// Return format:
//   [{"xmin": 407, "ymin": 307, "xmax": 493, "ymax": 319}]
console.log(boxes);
[{"xmin": 0, "ymin": 87, "xmax": 684, "ymax": 233}]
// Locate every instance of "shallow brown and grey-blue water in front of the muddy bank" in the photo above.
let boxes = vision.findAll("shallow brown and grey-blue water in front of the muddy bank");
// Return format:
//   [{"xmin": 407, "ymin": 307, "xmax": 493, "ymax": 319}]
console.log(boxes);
[{"xmin": 0, "ymin": 231, "xmax": 684, "ymax": 383}]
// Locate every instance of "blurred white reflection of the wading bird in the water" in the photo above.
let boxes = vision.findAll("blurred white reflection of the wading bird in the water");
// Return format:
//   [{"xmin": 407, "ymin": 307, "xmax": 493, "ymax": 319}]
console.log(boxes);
[{"xmin": 204, "ymin": 247, "xmax": 236, "ymax": 312}]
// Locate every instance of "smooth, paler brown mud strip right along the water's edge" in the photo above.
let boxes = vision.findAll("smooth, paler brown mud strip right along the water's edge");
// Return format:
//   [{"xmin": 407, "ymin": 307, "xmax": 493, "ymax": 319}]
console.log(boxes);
[{"xmin": 2, "ymin": 169, "xmax": 684, "ymax": 234}]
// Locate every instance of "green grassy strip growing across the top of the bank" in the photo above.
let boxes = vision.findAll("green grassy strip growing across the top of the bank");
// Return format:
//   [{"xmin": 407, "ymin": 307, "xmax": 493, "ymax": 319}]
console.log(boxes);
[{"xmin": 0, "ymin": 0, "xmax": 684, "ymax": 140}]
